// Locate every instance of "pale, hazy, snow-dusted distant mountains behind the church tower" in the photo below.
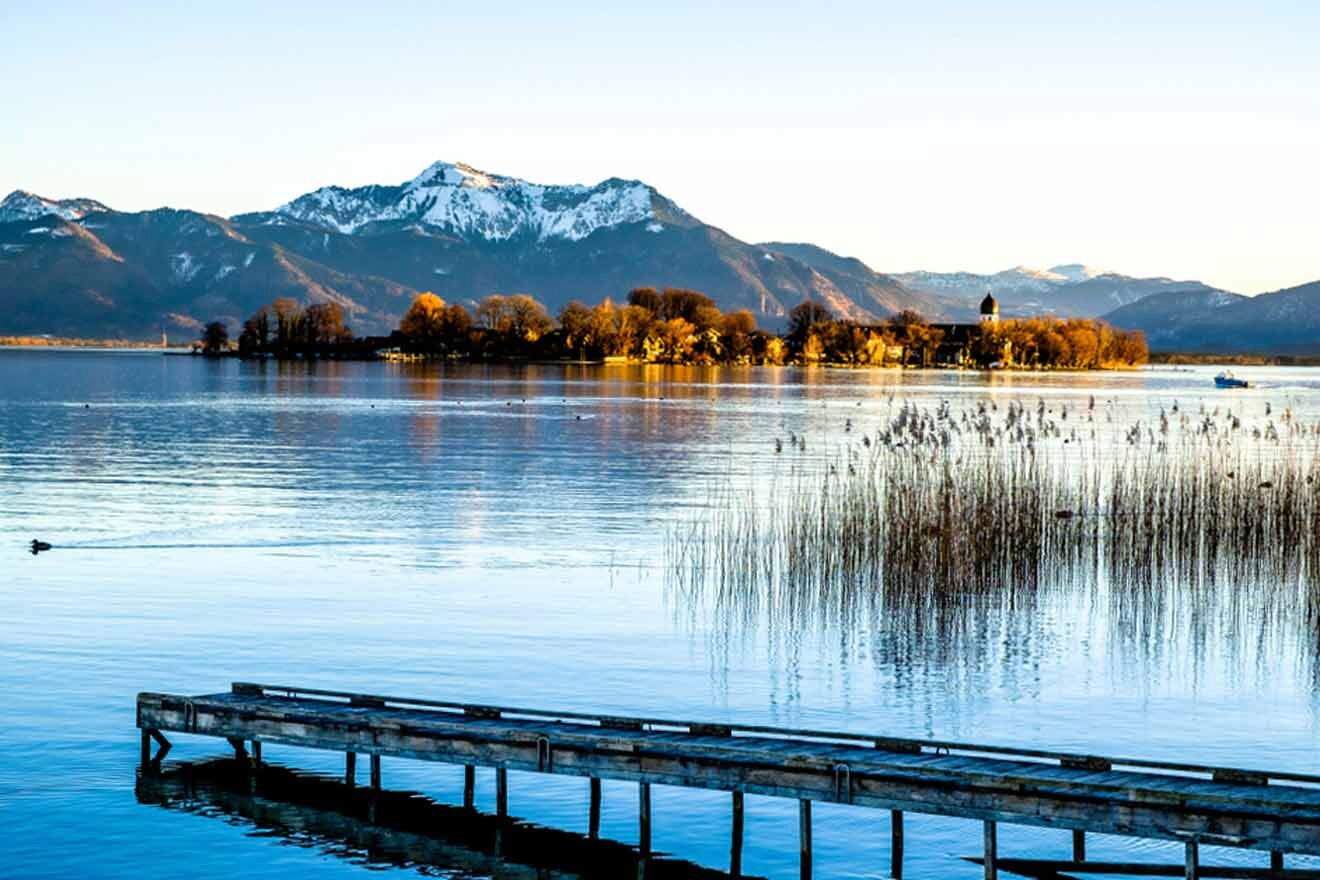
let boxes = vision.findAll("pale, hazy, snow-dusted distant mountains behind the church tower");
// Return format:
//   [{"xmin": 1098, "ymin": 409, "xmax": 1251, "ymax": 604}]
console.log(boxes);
[{"xmin": 894, "ymin": 264, "xmax": 1214, "ymax": 317}]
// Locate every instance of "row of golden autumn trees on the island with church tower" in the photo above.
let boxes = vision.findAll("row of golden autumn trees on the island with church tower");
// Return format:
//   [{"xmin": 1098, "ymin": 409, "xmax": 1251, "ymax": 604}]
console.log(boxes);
[{"xmin": 201, "ymin": 288, "xmax": 1148, "ymax": 369}]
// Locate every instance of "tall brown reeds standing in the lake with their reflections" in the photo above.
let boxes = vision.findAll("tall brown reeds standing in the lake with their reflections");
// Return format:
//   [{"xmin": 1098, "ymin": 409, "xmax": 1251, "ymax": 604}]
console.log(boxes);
[{"xmin": 665, "ymin": 402, "xmax": 1320, "ymax": 707}]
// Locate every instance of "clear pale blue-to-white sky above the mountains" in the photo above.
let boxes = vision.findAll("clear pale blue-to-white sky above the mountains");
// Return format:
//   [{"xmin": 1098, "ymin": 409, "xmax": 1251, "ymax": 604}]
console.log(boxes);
[{"xmin": 0, "ymin": 0, "xmax": 1320, "ymax": 293}]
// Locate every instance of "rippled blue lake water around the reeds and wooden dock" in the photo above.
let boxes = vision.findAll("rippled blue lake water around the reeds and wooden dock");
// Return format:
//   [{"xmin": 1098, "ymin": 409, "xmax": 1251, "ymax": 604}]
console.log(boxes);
[{"xmin": 0, "ymin": 350, "xmax": 1320, "ymax": 879}]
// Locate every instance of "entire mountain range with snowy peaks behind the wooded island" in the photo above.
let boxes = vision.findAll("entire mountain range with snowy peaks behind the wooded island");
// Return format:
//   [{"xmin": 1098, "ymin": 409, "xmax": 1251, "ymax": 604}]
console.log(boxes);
[{"xmin": 0, "ymin": 162, "xmax": 1320, "ymax": 351}]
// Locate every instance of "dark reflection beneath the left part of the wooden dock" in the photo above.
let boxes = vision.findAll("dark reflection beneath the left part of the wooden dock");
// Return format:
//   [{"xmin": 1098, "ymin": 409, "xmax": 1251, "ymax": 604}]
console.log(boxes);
[{"xmin": 137, "ymin": 759, "xmax": 760, "ymax": 880}]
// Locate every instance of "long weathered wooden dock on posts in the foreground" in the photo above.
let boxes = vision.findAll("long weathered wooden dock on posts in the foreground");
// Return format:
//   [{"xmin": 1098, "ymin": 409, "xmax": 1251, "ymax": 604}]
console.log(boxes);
[{"xmin": 137, "ymin": 683, "xmax": 1320, "ymax": 880}]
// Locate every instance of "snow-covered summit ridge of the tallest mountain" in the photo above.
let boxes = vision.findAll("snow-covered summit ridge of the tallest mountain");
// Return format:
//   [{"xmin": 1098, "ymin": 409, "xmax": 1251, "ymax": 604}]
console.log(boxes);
[{"xmin": 271, "ymin": 162, "xmax": 685, "ymax": 241}]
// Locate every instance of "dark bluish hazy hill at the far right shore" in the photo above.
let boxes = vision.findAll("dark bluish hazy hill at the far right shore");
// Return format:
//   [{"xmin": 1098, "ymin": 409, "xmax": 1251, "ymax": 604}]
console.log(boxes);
[{"xmin": 1105, "ymin": 281, "xmax": 1320, "ymax": 354}]
